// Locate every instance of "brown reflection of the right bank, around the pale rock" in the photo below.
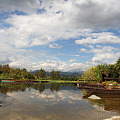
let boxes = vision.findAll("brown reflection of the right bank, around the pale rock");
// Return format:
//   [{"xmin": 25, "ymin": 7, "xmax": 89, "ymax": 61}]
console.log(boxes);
[{"xmin": 82, "ymin": 90, "xmax": 120, "ymax": 114}]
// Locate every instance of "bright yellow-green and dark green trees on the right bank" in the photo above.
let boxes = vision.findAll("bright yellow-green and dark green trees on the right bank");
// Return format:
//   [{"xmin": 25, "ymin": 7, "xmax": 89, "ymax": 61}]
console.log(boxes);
[{"xmin": 81, "ymin": 58, "xmax": 120, "ymax": 82}]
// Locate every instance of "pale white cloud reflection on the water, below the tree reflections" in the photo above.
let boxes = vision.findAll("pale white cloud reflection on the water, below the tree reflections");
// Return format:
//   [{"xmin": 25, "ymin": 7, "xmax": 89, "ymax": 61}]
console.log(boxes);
[{"xmin": 7, "ymin": 89, "xmax": 82, "ymax": 104}]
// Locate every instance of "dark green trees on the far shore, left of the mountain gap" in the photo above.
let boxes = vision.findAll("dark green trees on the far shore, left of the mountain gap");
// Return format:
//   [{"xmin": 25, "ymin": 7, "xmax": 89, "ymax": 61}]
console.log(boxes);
[{"xmin": 0, "ymin": 64, "xmax": 60, "ymax": 80}]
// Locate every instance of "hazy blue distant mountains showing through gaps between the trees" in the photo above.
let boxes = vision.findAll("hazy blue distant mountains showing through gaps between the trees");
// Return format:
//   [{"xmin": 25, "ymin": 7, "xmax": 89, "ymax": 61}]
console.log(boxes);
[{"xmin": 32, "ymin": 70, "xmax": 83, "ymax": 77}]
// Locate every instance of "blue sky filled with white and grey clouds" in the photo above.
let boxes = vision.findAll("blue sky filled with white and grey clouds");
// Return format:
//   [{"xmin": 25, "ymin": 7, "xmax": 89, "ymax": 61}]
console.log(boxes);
[{"xmin": 0, "ymin": 0, "xmax": 120, "ymax": 71}]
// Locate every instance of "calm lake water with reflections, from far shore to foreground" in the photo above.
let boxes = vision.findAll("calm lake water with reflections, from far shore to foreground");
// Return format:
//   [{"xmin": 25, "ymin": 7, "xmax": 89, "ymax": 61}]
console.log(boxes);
[{"xmin": 0, "ymin": 83, "xmax": 120, "ymax": 120}]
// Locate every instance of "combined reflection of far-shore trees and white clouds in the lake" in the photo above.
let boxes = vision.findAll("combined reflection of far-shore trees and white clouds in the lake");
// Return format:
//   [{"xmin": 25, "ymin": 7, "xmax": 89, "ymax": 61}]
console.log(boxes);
[{"xmin": 0, "ymin": 83, "xmax": 82, "ymax": 104}]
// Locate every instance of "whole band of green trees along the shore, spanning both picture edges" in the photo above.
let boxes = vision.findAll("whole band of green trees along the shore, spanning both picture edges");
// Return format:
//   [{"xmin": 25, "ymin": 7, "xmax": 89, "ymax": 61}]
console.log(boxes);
[{"xmin": 0, "ymin": 58, "xmax": 120, "ymax": 82}]
